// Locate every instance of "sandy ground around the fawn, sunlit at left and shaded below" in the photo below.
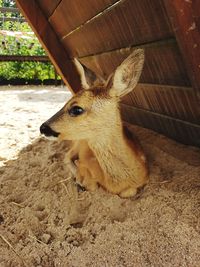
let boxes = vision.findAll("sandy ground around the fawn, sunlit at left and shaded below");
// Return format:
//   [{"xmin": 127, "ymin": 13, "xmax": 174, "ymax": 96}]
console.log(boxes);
[{"xmin": 0, "ymin": 87, "xmax": 200, "ymax": 267}]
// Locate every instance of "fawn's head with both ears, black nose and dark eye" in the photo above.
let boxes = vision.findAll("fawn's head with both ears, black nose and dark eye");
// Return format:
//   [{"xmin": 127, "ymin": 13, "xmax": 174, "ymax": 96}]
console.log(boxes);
[{"xmin": 40, "ymin": 49, "xmax": 144, "ymax": 140}]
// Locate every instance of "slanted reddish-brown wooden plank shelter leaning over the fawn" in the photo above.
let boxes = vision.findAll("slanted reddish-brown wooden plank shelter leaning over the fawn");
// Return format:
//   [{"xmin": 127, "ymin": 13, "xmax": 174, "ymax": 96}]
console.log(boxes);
[{"xmin": 17, "ymin": 0, "xmax": 200, "ymax": 146}]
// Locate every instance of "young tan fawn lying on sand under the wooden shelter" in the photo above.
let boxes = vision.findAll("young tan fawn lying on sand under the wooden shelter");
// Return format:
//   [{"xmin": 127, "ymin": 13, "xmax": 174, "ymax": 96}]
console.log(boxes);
[{"xmin": 40, "ymin": 49, "xmax": 148, "ymax": 197}]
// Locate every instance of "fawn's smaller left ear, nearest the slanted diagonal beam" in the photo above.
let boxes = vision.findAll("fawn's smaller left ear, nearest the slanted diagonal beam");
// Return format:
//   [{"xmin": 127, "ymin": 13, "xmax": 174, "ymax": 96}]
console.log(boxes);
[{"xmin": 74, "ymin": 58, "xmax": 104, "ymax": 90}]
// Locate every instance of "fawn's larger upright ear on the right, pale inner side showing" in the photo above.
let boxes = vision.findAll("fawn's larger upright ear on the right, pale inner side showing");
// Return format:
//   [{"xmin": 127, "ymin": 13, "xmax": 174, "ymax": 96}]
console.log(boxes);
[{"xmin": 107, "ymin": 49, "xmax": 144, "ymax": 97}]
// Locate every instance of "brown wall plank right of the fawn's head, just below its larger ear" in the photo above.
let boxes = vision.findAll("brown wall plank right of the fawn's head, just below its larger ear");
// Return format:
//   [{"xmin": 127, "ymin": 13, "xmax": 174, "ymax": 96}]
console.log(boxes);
[{"xmin": 122, "ymin": 84, "xmax": 200, "ymax": 125}]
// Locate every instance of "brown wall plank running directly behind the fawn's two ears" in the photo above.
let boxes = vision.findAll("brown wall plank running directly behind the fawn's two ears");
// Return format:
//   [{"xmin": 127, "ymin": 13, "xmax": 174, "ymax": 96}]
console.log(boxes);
[{"xmin": 80, "ymin": 39, "xmax": 190, "ymax": 86}]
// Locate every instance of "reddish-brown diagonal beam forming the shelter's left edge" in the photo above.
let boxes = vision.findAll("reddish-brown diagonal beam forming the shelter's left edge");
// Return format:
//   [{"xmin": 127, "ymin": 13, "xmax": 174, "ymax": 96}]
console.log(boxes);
[{"xmin": 17, "ymin": 0, "xmax": 80, "ymax": 91}]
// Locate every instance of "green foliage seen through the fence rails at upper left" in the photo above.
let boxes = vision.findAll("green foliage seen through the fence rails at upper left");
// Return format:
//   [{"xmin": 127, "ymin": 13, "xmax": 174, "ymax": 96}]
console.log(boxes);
[{"xmin": 0, "ymin": 0, "xmax": 58, "ymax": 80}]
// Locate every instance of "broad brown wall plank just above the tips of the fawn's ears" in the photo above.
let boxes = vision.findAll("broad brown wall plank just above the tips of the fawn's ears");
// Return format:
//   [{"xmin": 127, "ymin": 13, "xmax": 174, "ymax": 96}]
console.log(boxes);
[{"xmin": 62, "ymin": 0, "xmax": 173, "ymax": 57}]
